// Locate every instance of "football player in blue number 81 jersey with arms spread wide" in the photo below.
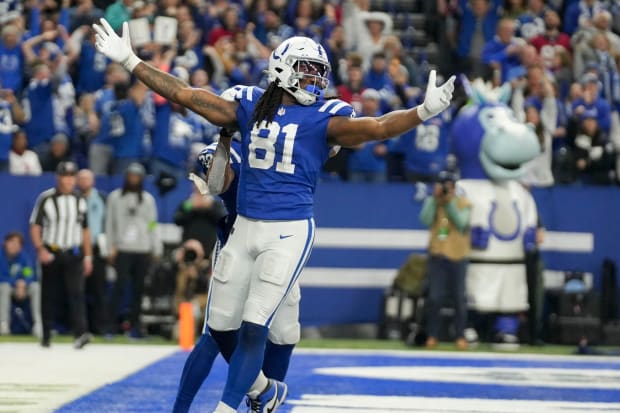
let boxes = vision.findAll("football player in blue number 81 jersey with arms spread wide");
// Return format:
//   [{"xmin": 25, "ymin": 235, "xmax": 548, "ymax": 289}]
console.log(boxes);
[{"xmin": 94, "ymin": 19, "xmax": 454, "ymax": 413}]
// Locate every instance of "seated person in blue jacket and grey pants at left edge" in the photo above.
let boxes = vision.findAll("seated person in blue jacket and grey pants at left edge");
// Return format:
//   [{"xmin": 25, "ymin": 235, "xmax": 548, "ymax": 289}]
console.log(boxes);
[{"xmin": 0, "ymin": 232, "xmax": 42, "ymax": 338}]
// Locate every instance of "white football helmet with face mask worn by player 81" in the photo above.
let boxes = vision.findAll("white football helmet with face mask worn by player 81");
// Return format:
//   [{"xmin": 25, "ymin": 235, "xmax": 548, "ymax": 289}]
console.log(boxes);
[{"xmin": 267, "ymin": 36, "xmax": 331, "ymax": 106}]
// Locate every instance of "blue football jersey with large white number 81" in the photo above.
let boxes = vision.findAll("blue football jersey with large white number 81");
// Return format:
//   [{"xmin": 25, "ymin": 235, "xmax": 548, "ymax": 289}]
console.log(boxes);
[{"xmin": 235, "ymin": 86, "xmax": 355, "ymax": 220}]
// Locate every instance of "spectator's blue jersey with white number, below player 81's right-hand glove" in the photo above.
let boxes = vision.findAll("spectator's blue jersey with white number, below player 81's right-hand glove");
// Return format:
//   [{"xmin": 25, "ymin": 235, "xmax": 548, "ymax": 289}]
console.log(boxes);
[{"xmin": 399, "ymin": 112, "xmax": 450, "ymax": 176}]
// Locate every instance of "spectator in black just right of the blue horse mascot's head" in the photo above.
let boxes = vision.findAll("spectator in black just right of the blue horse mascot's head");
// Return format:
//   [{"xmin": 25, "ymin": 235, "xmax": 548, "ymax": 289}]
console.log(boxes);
[{"xmin": 573, "ymin": 108, "xmax": 616, "ymax": 185}]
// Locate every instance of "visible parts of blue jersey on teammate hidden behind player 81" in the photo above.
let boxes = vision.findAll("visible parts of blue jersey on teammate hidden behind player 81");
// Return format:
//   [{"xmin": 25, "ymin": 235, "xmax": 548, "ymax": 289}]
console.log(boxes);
[{"xmin": 198, "ymin": 141, "xmax": 241, "ymax": 245}]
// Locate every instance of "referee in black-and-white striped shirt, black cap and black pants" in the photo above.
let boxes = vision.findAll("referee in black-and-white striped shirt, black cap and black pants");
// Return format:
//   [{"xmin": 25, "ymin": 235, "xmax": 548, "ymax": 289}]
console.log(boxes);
[{"xmin": 30, "ymin": 162, "xmax": 92, "ymax": 349}]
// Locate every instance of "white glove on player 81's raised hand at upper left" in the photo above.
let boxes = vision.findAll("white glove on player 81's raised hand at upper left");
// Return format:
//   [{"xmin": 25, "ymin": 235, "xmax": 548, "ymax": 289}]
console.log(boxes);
[{"xmin": 93, "ymin": 18, "xmax": 142, "ymax": 72}]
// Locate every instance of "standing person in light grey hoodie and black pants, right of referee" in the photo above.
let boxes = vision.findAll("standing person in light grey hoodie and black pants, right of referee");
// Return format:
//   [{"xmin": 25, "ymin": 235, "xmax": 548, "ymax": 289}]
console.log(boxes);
[{"xmin": 105, "ymin": 162, "xmax": 162, "ymax": 338}]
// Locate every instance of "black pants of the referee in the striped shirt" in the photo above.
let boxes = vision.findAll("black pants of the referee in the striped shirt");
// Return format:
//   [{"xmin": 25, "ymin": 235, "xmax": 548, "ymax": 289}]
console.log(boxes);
[{"xmin": 41, "ymin": 251, "xmax": 86, "ymax": 342}]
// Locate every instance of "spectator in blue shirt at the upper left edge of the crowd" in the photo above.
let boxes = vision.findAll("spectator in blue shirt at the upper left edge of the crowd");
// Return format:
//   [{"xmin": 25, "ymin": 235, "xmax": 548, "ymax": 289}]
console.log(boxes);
[{"xmin": 0, "ymin": 24, "xmax": 24, "ymax": 93}]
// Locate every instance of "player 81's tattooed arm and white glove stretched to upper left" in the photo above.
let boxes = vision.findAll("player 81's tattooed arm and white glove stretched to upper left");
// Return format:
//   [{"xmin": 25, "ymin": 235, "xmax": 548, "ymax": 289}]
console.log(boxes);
[{"xmin": 93, "ymin": 19, "xmax": 237, "ymax": 128}]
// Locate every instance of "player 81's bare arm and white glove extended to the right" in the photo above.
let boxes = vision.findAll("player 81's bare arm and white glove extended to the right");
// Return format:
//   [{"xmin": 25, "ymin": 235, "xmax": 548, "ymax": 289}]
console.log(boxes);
[{"xmin": 327, "ymin": 70, "xmax": 454, "ymax": 147}]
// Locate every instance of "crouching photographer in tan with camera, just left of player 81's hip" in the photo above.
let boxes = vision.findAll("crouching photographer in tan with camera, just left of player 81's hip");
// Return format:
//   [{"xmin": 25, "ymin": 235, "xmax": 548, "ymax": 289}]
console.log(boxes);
[{"xmin": 174, "ymin": 239, "xmax": 210, "ymax": 318}]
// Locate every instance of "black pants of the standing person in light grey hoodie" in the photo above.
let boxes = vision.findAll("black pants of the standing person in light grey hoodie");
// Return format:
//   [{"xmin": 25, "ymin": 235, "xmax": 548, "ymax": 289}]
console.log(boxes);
[{"xmin": 108, "ymin": 252, "xmax": 150, "ymax": 334}]
